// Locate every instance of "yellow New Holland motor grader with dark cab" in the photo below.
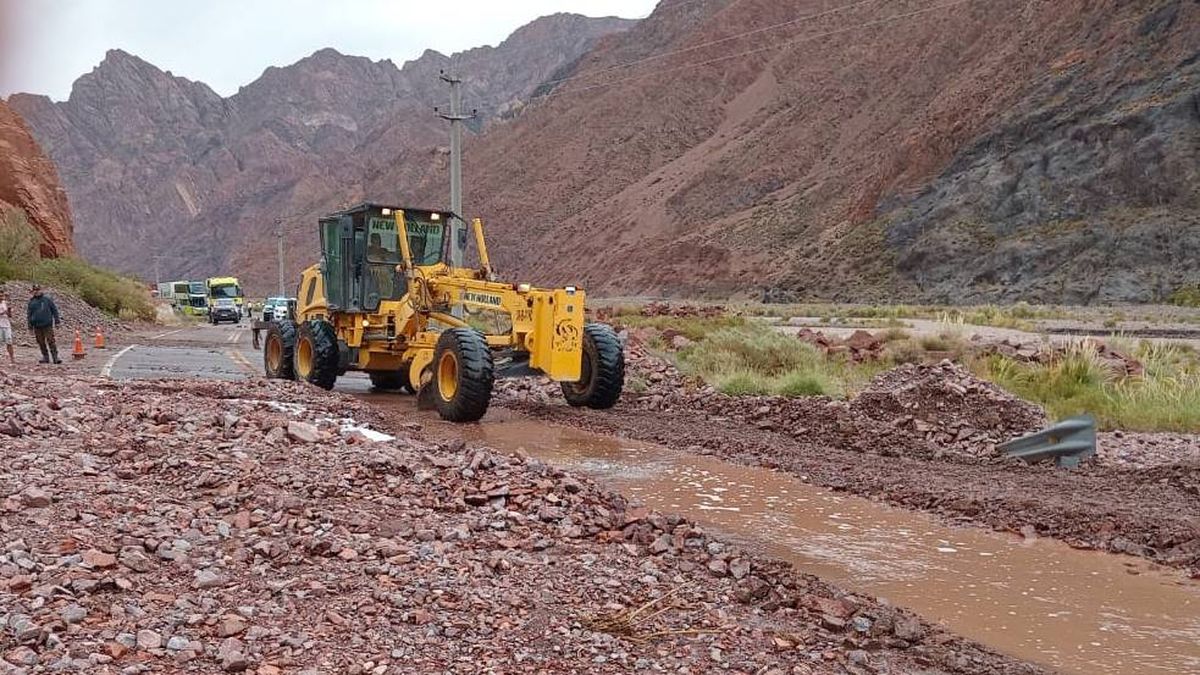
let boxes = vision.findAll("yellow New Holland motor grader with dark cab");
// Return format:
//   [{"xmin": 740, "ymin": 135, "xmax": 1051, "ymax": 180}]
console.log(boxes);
[{"xmin": 263, "ymin": 203, "xmax": 625, "ymax": 422}]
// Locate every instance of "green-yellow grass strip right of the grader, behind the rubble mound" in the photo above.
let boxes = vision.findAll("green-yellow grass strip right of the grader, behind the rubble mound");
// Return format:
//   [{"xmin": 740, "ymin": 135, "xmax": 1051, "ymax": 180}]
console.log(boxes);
[{"xmin": 617, "ymin": 312, "xmax": 1200, "ymax": 432}]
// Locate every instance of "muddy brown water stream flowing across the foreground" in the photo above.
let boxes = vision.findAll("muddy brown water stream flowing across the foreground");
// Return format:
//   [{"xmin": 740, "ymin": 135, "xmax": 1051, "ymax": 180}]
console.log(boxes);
[{"xmin": 364, "ymin": 395, "xmax": 1200, "ymax": 674}]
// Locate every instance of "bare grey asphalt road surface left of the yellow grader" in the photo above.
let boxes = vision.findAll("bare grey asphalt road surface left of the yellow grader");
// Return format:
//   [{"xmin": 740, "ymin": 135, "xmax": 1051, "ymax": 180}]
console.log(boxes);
[{"xmin": 101, "ymin": 323, "xmax": 371, "ymax": 393}]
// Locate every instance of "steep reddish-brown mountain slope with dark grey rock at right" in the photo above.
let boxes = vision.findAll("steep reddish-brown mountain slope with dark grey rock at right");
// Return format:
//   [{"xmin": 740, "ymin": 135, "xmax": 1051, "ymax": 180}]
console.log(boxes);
[{"xmin": 410, "ymin": 0, "xmax": 1200, "ymax": 303}]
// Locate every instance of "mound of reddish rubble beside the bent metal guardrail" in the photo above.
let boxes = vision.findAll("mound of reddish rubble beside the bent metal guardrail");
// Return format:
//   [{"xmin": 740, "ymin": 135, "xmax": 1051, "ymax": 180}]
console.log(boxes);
[{"xmin": 850, "ymin": 360, "xmax": 1046, "ymax": 456}]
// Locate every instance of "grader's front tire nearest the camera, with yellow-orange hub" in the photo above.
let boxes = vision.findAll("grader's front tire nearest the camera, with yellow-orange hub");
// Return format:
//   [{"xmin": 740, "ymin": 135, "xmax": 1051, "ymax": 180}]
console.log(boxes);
[{"xmin": 427, "ymin": 328, "xmax": 496, "ymax": 422}]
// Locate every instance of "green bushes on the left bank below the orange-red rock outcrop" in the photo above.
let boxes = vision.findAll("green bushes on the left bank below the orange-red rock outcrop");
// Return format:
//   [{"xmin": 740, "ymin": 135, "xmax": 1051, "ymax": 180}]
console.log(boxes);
[{"xmin": 0, "ymin": 210, "xmax": 155, "ymax": 321}]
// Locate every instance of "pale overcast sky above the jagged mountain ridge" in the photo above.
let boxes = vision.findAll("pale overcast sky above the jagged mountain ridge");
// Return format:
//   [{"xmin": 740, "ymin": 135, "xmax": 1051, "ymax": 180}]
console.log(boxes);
[{"xmin": 0, "ymin": 0, "xmax": 656, "ymax": 100}]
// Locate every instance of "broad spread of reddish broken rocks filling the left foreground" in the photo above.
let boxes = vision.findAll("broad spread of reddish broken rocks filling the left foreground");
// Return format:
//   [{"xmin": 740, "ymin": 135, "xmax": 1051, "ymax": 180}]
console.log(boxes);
[{"xmin": 0, "ymin": 375, "xmax": 1037, "ymax": 675}]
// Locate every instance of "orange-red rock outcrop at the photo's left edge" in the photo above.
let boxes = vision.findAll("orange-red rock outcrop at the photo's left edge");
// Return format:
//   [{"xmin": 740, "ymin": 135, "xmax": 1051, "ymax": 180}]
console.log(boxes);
[{"xmin": 0, "ymin": 101, "xmax": 74, "ymax": 258}]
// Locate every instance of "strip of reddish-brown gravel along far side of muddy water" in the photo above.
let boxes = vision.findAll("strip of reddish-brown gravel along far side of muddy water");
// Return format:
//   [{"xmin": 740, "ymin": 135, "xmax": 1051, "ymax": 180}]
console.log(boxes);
[{"xmin": 508, "ymin": 402, "xmax": 1200, "ymax": 574}]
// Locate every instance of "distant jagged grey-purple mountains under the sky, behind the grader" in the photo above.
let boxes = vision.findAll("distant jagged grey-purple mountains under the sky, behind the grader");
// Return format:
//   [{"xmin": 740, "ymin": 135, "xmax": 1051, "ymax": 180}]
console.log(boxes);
[{"xmin": 10, "ymin": 14, "xmax": 630, "ymax": 288}]
